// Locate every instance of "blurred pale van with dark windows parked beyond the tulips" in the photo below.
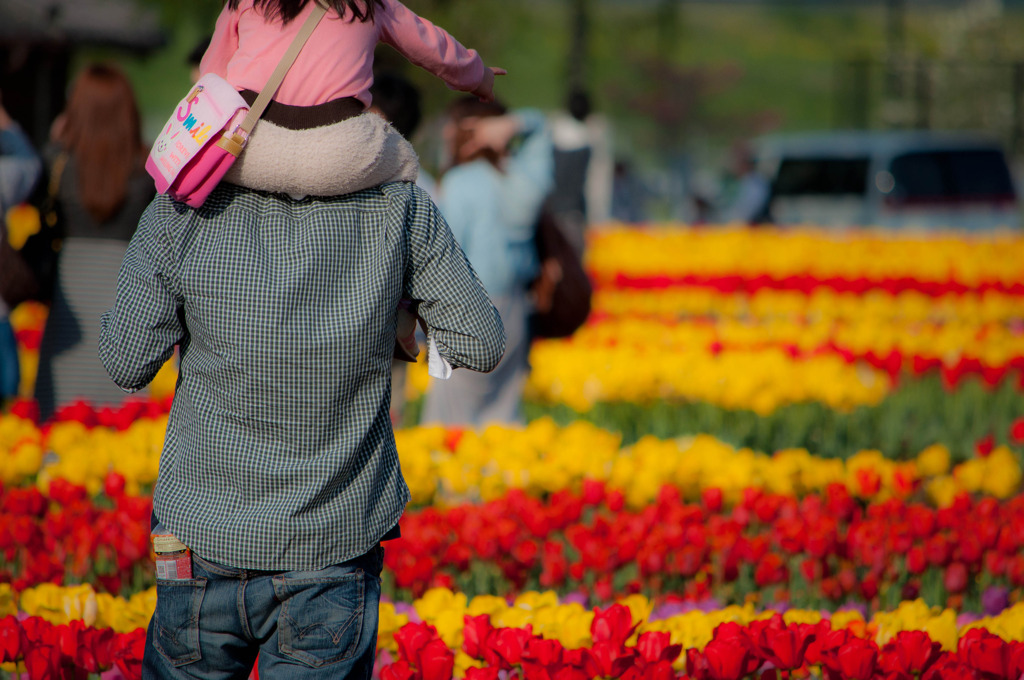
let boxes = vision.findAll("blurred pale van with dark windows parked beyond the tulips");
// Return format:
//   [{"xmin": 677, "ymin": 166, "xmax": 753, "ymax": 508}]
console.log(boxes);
[{"xmin": 754, "ymin": 131, "xmax": 1021, "ymax": 229}]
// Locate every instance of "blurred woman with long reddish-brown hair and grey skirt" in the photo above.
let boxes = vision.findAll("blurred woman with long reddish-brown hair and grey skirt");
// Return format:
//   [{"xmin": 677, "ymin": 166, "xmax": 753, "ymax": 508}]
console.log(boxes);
[{"xmin": 35, "ymin": 63, "xmax": 155, "ymax": 419}]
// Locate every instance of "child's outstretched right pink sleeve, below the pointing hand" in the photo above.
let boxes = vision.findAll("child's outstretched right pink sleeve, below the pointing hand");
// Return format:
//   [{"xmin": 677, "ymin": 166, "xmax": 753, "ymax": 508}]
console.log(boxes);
[{"xmin": 374, "ymin": 0, "xmax": 484, "ymax": 92}]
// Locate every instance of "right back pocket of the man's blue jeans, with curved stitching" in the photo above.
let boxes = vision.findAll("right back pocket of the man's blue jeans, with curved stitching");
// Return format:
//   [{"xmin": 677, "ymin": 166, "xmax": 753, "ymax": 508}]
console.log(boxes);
[{"xmin": 273, "ymin": 569, "xmax": 367, "ymax": 668}]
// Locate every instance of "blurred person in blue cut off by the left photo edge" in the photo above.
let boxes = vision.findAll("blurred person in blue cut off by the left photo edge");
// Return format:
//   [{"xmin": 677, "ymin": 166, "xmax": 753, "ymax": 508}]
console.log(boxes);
[{"xmin": 0, "ymin": 98, "xmax": 43, "ymax": 402}]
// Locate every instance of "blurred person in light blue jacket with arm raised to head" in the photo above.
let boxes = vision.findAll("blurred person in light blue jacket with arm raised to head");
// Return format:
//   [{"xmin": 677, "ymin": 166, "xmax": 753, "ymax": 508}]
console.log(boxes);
[{"xmin": 422, "ymin": 97, "xmax": 554, "ymax": 426}]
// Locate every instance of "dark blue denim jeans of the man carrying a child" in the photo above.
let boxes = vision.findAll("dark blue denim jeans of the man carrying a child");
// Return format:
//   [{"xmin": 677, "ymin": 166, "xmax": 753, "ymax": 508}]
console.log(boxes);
[{"xmin": 142, "ymin": 544, "xmax": 384, "ymax": 680}]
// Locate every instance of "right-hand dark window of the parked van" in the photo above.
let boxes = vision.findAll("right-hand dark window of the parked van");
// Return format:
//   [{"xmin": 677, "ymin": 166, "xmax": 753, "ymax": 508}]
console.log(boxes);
[{"xmin": 890, "ymin": 150, "xmax": 1015, "ymax": 203}]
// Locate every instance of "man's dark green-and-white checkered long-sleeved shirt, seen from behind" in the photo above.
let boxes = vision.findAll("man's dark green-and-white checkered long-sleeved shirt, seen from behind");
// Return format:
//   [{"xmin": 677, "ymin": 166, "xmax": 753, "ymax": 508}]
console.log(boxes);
[{"xmin": 99, "ymin": 183, "xmax": 505, "ymax": 570}]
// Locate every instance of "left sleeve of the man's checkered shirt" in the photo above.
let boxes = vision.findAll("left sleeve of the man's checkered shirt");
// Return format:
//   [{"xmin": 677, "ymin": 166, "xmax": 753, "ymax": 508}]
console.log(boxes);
[{"xmin": 99, "ymin": 197, "xmax": 185, "ymax": 392}]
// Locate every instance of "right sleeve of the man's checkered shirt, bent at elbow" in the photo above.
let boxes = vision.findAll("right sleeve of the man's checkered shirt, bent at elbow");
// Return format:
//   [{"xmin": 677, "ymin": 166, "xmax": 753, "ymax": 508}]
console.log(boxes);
[{"xmin": 395, "ymin": 186, "xmax": 505, "ymax": 373}]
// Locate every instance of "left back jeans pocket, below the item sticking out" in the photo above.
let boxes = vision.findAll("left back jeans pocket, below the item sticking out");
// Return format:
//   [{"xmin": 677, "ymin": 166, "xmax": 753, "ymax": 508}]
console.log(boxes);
[{"xmin": 153, "ymin": 579, "xmax": 206, "ymax": 666}]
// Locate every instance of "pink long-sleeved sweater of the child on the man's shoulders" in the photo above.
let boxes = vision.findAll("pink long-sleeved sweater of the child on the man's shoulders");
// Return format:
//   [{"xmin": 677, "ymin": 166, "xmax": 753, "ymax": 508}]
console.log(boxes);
[{"xmin": 200, "ymin": 0, "xmax": 484, "ymax": 107}]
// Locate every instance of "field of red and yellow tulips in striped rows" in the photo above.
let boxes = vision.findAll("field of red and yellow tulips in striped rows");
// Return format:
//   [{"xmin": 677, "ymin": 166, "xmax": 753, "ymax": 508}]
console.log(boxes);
[{"xmin": 0, "ymin": 225, "xmax": 1024, "ymax": 680}]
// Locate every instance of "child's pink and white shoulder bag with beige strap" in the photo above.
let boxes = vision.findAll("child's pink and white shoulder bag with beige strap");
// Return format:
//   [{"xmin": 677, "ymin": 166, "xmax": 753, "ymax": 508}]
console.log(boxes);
[{"xmin": 145, "ymin": 1, "xmax": 327, "ymax": 208}]
